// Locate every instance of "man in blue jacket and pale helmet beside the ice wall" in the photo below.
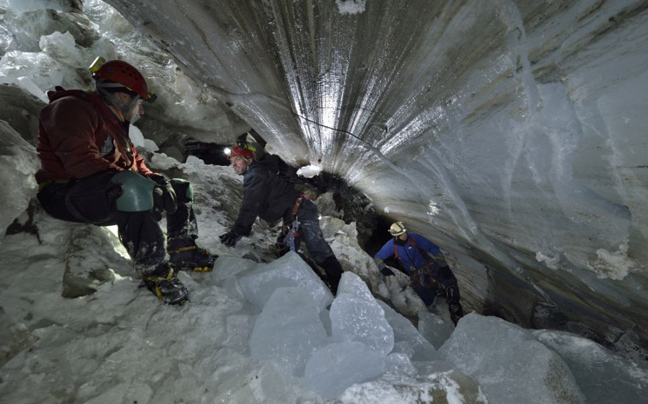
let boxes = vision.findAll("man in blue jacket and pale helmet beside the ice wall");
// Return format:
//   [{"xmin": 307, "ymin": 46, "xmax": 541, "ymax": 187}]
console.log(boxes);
[{"xmin": 374, "ymin": 222, "xmax": 463, "ymax": 324}]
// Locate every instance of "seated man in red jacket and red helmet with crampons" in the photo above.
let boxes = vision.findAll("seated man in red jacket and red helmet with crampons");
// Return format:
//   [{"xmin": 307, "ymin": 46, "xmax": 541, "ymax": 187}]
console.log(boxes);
[{"xmin": 36, "ymin": 57, "xmax": 217, "ymax": 304}]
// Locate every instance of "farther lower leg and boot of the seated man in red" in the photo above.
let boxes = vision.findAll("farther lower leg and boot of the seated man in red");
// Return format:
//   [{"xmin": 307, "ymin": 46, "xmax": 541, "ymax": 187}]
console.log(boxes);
[{"xmin": 167, "ymin": 178, "xmax": 218, "ymax": 272}]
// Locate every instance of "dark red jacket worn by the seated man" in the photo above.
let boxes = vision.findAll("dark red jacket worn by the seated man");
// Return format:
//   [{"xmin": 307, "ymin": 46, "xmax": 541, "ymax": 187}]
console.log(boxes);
[{"xmin": 36, "ymin": 87, "xmax": 153, "ymax": 183}]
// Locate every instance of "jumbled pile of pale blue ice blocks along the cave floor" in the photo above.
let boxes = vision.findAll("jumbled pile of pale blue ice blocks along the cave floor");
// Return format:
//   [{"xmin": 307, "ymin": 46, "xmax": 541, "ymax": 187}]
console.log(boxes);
[{"xmin": 217, "ymin": 253, "xmax": 648, "ymax": 404}]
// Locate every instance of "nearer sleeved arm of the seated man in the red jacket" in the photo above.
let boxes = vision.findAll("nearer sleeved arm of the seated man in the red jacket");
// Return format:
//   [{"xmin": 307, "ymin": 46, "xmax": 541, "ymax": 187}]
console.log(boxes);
[{"xmin": 41, "ymin": 97, "xmax": 123, "ymax": 178}]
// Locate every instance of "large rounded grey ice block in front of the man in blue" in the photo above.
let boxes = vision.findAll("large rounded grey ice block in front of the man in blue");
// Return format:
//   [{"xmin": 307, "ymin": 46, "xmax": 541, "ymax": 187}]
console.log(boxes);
[{"xmin": 439, "ymin": 314, "xmax": 586, "ymax": 404}]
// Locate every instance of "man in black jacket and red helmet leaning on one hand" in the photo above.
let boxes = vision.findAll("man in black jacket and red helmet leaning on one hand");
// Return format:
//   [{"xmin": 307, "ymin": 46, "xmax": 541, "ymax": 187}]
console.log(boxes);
[{"xmin": 220, "ymin": 144, "xmax": 344, "ymax": 294}]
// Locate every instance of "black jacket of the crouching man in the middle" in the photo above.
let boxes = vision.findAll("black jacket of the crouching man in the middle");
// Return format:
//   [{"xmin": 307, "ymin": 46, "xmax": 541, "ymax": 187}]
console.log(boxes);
[{"xmin": 233, "ymin": 159, "xmax": 300, "ymax": 236}]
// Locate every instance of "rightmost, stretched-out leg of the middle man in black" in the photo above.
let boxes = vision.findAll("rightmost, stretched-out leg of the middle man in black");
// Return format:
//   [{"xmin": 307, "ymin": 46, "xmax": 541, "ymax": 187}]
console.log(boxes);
[{"xmin": 297, "ymin": 200, "xmax": 344, "ymax": 294}]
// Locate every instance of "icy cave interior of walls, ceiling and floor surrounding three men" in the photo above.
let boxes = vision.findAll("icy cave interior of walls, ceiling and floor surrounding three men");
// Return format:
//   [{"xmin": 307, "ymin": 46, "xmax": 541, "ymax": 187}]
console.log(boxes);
[{"xmin": 0, "ymin": 0, "xmax": 648, "ymax": 404}]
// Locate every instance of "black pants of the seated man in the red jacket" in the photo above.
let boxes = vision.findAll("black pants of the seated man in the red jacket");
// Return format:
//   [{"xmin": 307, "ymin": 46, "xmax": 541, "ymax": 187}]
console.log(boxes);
[{"xmin": 38, "ymin": 172, "xmax": 198, "ymax": 272}]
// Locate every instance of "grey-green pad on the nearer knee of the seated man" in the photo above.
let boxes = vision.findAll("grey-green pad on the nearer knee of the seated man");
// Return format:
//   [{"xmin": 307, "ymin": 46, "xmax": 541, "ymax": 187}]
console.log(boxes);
[{"xmin": 111, "ymin": 171, "xmax": 155, "ymax": 212}]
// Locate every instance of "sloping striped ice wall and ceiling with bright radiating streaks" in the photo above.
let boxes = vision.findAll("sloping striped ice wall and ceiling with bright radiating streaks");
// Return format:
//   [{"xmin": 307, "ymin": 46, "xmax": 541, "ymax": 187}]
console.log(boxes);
[{"xmin": 108, "ymin": 0, "xmax": 648, "ymax": 347}]
